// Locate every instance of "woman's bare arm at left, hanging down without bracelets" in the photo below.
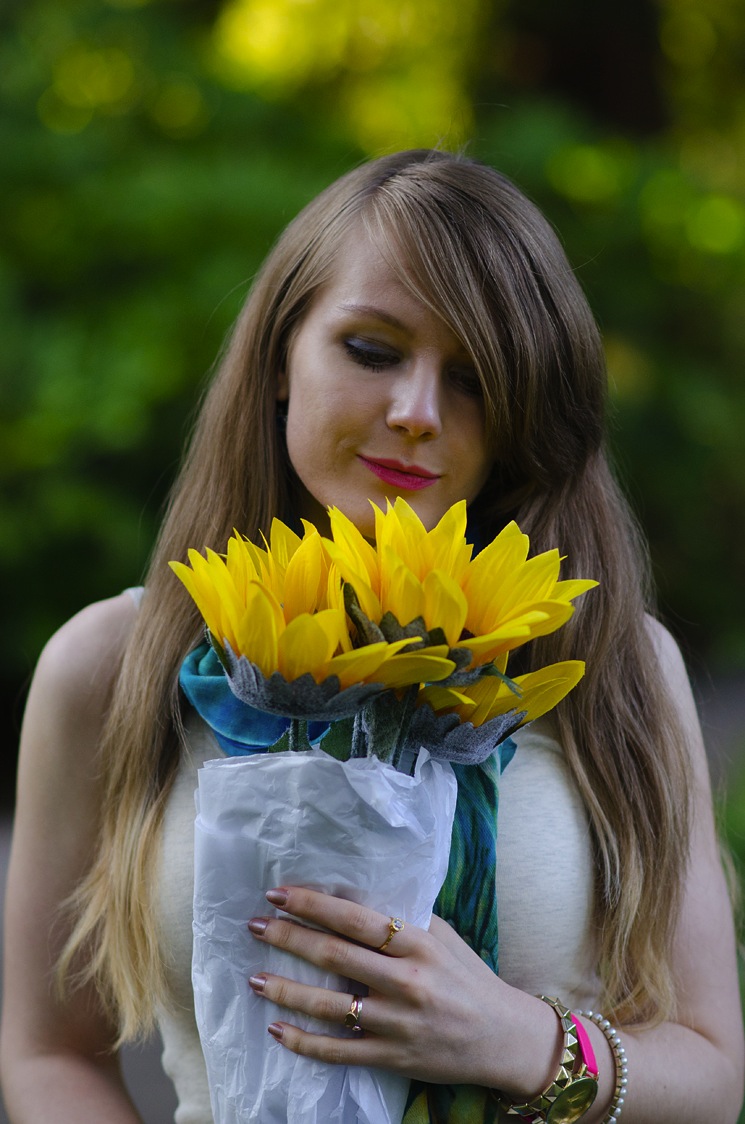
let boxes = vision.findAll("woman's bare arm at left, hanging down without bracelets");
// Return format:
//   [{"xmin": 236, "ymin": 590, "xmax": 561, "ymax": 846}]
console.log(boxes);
[{"xmin": 0, "ymin": 595, "xmax": 144, "ymax": 1124}]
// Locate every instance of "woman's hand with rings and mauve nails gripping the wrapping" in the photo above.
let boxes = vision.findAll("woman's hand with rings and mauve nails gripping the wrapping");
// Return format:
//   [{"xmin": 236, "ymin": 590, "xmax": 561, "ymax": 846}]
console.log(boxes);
[{"xmin": 248, "ymin": 888, "xmax": 530, "ymax": 1086}]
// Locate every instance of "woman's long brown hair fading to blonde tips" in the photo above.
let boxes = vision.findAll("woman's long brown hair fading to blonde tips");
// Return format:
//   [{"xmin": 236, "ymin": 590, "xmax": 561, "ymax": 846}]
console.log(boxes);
[{"xmin": 60, "ymin": 149, "xmax": 689, "ymax": 1041}]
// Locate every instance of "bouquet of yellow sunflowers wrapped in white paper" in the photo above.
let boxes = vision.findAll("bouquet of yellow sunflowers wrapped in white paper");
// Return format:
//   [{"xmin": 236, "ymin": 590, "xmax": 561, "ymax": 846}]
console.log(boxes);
[{"xmin": 171, "ymin": 499, "xmax": 596, "ymax": 1124}]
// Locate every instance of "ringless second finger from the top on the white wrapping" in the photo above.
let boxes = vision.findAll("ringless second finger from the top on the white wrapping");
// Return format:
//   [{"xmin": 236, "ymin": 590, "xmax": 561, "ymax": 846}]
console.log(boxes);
[{"xmin": 248, "ymin": 917, "xmax": 396, "ymax": 992}]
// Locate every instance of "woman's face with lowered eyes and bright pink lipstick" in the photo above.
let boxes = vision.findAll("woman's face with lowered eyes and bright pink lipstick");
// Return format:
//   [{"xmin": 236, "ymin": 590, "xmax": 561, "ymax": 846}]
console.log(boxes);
[{"xmin": 278, "ymin": 230, "xmax": 494, "ymax": 535}]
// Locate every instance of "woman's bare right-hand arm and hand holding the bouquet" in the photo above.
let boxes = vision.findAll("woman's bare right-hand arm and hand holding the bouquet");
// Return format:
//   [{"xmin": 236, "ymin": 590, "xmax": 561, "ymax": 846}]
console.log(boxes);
[{"xmin": 241, "ymin": 627, "xmax": 744, "ymax": 1124}]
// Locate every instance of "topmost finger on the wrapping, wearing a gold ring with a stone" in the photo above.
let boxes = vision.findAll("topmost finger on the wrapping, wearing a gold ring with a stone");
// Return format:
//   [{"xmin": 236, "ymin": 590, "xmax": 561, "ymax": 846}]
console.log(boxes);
[{"xmin": 261, "ymin": 886, "xmax": 413, "ymax": 957}]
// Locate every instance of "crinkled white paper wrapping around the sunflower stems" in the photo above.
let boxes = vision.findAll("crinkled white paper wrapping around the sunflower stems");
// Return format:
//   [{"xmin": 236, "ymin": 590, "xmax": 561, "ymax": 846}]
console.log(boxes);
[{"xmin": 192, "ymin": 750, "xmax": 457, "ymax": 1124}]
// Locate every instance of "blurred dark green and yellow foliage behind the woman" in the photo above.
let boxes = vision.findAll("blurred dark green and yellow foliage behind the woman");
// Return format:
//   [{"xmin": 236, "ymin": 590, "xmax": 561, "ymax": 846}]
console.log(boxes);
[{"xmin": 0, "ymin": 0, "xmax": 745, "ymax": 799}]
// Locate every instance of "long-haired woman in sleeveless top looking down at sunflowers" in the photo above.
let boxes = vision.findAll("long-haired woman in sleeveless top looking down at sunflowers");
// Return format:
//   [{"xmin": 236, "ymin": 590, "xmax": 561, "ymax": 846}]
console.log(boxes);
[{"xmin": 2, "ymin": 152, "xmax": 743, "ymax": 1124}]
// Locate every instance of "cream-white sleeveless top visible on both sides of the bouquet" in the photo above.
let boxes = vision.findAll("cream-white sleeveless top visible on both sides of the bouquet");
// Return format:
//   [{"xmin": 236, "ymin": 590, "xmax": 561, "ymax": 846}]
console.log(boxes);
[{"xmin": 150, "ymin": 711, "xmax": 600, "ymax": 1124}]
